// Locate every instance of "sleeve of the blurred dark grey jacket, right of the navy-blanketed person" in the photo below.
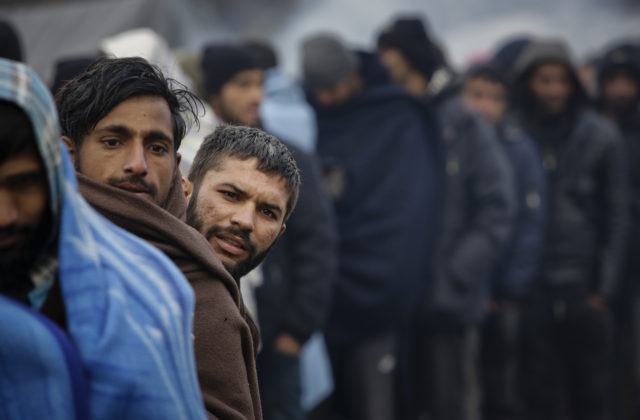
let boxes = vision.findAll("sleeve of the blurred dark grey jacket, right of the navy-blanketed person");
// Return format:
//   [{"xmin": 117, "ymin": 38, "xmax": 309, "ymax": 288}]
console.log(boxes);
[{"xmin": 448, "ymin": 116, "xmax": 516, "ymax": 288}]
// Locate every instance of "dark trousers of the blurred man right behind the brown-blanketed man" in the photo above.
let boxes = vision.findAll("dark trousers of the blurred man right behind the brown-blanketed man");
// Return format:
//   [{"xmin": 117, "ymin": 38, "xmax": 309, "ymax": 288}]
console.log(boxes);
[{"xmin": 257, "ymin": 348, "xmax": 305, "ymax": 420}]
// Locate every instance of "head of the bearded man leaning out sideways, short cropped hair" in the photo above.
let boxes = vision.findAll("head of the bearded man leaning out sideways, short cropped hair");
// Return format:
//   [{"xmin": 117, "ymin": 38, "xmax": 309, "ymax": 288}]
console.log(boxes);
[{"xmin": 184, "ymin": 126, "xmax": 300, "ymax": 278}]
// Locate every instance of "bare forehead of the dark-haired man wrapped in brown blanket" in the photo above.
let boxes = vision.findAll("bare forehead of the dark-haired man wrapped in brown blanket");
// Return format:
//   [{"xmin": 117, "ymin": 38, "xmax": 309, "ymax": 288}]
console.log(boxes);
[{"xmin": 94, "ymin": 96, "xmax": 173, "ymax": 138}]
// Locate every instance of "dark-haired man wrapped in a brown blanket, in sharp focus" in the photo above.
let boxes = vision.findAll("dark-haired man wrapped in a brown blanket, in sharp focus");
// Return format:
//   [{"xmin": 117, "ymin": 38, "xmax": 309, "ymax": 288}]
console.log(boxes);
[{"xmin": 56, "ymin": 58, "xmax": 262, "ymax": 419}]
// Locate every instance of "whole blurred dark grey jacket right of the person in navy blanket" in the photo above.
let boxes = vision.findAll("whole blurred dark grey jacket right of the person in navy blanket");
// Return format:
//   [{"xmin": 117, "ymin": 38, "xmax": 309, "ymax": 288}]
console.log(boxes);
[{"xmin": 423, "ymin": 98, "xmax": 516, "ymax": 328}]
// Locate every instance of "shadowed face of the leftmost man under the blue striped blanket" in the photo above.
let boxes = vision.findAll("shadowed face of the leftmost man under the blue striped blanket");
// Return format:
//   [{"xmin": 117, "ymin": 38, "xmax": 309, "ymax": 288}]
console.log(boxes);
[{"xmin": 0, "ymin": 145, "xmax": 49, "ymax": 270}]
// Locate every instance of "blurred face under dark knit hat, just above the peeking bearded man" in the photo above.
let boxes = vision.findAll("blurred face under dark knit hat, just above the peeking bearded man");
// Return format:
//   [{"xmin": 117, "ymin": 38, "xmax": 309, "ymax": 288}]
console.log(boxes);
[{"xmin": 210, "ymin": 70, "xmax": 264, "ymax": 127}]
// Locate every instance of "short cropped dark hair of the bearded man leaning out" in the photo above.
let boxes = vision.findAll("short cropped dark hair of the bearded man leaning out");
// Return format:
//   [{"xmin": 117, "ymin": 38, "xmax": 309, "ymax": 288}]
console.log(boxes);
[{"xmin": 189, "ymin": 125, "xmax": 301, "ymax": 221}]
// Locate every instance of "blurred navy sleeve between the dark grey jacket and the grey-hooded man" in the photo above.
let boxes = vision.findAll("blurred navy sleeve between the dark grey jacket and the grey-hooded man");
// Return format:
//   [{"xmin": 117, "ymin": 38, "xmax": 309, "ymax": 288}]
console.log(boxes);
[{"xmin": 498, "ymin": 137, "xmax": 546, "ymax": 298}]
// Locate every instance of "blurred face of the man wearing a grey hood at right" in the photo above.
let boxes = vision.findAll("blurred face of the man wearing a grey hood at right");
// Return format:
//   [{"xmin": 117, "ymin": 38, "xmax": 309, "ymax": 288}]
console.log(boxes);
[{"xmin": 529, "ymin": 63, "xmax": 572, "ymax": 115}]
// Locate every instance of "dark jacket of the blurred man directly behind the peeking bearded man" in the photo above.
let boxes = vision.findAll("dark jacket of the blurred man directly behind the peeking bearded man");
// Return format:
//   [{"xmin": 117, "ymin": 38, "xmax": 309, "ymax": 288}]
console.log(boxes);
[{"xmin": 256, "ymin": 145, "xmax": 338, "ymax": 346}]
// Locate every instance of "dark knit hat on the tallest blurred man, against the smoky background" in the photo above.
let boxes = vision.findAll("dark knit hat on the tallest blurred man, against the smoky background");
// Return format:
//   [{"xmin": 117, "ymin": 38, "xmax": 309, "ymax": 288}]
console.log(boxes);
[{"xmin": 378, "ymin": 17, "xmax": 445, "ymax": 80}]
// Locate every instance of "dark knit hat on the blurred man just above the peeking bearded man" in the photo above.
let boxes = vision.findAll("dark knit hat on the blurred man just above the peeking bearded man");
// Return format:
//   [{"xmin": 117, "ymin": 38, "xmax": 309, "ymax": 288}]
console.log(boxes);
[{"xmin": 202, "ymin": 45, "xmax": 260, "ymax": 95}]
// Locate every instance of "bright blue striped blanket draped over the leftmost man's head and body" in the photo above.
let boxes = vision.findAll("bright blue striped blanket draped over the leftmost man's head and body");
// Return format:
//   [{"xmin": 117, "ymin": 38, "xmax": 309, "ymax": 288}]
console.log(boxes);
[{"xmin": 0, "ymin": 60, "xmax": 205, "ymax": 419}]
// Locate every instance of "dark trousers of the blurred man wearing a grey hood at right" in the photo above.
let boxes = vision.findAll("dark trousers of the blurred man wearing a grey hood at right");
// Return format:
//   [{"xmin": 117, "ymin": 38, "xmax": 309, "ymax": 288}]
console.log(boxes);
[{"xmin": 523, "ymin": 297, "xmax": 611, "ymax": 420}]
